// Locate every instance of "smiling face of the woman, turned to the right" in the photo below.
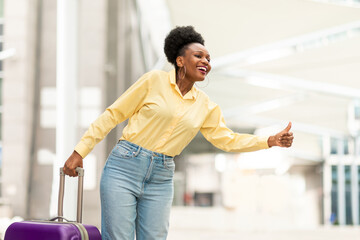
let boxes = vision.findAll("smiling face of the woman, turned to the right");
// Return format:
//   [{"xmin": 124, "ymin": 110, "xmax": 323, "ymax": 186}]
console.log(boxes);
[{"xmin": 176, "ymin": 43, "xmax": 211, "ymax": 82}]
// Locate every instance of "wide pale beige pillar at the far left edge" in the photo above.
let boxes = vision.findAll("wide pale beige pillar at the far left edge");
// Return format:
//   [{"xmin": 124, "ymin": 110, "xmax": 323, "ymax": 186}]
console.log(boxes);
[{"xmin": 2, "ymin": 0, "xmax": 38, "ymax": 217}]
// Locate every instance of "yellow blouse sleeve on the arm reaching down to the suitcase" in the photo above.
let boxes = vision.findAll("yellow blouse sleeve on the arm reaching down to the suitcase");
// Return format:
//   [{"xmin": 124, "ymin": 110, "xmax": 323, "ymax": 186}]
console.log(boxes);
[{"xmin": 75, "ymin": 73, "xmax": 151, "ymax": 158}]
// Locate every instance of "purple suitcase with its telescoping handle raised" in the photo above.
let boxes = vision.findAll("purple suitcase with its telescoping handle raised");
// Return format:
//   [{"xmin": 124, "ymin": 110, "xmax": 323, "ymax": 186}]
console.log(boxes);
[{"xmin": 4, "ymin": 168, "xmax": 101, "ymax": 240}]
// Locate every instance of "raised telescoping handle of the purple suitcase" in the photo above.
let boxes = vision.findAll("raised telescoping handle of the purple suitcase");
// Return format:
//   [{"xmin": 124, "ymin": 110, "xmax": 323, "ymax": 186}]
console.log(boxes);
[{"xmin": 58, "ymin": 167, "xmax": 84, "ymax": 223}]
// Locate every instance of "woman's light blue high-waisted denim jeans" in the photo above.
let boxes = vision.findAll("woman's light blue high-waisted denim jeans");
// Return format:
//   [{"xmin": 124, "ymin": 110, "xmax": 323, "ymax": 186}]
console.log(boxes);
[{"xmin": 100, "ymin": 141, "xmax": 175, "ymax": 240}]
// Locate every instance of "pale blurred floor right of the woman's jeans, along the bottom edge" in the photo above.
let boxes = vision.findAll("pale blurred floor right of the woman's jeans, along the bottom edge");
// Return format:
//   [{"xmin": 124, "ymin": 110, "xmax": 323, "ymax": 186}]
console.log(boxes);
[{"xmin": 168, "ymin": 207, "xmax": 360, "ymax": 240}]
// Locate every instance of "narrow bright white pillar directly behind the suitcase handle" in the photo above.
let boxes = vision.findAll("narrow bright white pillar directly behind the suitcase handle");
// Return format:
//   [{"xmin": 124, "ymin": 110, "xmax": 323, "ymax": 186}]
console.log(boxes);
[{"xmin": 50, "ymin": 0, "xmax": 78, "ymax": 220}]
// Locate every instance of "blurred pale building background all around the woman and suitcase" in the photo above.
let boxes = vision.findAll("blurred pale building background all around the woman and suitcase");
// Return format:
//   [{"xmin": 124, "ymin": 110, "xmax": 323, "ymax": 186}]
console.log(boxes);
[{"xmin": 0, "ymin": 0, "xmax": 360, "ymax": 240}]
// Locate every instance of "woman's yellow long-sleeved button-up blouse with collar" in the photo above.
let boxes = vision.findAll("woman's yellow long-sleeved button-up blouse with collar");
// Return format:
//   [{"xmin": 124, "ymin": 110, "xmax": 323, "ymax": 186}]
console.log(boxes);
[{"xmin": 75, "ymin": 70, "xmax": 268, "ymax": 158}]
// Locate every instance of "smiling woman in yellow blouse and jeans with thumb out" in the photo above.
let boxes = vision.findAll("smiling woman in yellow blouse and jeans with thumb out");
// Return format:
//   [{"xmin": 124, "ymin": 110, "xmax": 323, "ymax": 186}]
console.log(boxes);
[{"xmin": 64, "ymin": 26, "xmax": 293, "ymax": 240}]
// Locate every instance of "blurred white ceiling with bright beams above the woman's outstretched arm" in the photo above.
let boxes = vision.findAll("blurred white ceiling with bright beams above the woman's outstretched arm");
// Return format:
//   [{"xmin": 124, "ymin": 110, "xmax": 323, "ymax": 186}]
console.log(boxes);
[{"xmin": 146, "ymin": 0, "xmax": 360, "ymax": 161}]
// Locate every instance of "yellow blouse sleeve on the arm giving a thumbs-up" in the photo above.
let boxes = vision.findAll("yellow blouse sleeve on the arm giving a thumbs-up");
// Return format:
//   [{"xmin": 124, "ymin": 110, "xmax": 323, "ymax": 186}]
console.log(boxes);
[{"xmin": 200, "ymin": 102, "xmax": 269, "ymax": 152}]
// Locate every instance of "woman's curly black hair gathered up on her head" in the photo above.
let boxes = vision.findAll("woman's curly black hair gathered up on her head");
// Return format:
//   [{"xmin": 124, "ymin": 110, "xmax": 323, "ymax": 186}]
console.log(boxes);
[{"xmin": 164, "ymin": 26, "xmax": 205, "ymax": 69}]
